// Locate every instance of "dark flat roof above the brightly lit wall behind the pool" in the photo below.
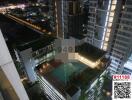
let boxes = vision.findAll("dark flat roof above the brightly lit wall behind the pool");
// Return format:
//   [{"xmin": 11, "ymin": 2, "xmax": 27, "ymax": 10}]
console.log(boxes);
[{"xmin": 75, "ymin": 43, "xmax": 106, "ymax": 62}]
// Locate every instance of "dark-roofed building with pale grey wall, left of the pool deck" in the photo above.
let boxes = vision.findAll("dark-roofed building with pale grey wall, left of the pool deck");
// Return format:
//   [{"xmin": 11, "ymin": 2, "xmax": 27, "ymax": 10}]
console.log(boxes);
[{"xmin": 14, "ymin": 35, "xmax": 55, "ymax": 82}]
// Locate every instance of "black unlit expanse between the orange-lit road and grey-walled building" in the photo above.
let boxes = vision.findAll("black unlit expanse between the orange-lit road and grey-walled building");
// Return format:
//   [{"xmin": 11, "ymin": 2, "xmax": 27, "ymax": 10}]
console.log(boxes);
[{"xmin": 0, "ymin": 14, "xmax": 55, "ymax": 51}]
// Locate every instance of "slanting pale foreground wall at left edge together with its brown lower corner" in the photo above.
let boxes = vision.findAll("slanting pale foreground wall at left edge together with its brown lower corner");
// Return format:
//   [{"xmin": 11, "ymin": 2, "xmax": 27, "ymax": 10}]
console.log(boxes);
[{"xmin": 0, "ymin": 30, "xmax": 29, "ymax": 100}]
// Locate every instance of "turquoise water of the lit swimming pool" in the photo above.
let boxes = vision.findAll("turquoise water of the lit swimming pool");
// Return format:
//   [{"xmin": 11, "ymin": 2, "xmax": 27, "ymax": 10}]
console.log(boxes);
[{"xmin": 51, "ymin": 62, "xmax": 87, "ymax": 84}]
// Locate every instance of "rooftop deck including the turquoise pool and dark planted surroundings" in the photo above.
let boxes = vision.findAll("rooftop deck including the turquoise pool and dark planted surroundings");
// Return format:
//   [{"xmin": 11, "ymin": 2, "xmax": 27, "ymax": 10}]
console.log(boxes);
[{"xmin": 37, "ymin": 56, "xmax": 108, "ymax": 97}]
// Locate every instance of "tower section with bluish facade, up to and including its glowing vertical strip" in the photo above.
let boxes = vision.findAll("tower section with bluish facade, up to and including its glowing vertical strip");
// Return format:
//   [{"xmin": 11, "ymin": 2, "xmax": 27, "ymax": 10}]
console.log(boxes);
[{"xmin": 84, "ymin": 0, "xmax": 115, "ymax": 50}]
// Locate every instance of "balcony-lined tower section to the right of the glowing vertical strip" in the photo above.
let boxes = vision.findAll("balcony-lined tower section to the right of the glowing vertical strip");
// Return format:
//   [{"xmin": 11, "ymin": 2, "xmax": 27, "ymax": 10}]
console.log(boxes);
[{"xmin": 105, "ymin": 0, "xmax": 132, "ymax": 74}]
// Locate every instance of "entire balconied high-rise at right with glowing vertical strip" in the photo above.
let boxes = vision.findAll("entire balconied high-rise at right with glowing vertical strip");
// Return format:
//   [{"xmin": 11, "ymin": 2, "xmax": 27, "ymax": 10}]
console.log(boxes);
[{"xmin": 84, "ymin": 0, "xmax": 132, "ymax": 74}]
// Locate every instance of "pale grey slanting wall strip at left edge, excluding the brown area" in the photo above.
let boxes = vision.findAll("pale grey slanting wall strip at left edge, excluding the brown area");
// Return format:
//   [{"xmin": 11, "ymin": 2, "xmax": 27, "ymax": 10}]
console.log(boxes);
[{"xmin": 0, "ymin": 30, "xmax": 29, "ymax": 100}]
